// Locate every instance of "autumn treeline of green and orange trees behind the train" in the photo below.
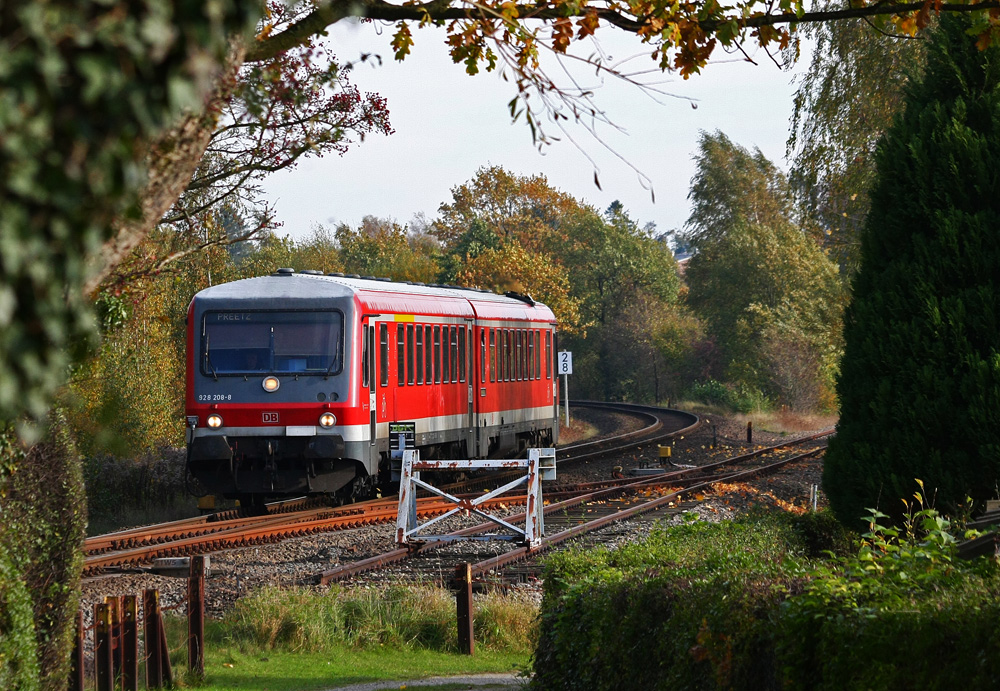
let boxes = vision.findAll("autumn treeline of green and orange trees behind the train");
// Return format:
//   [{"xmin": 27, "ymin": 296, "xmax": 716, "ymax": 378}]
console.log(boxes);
[{"xmin": 63, "ymin": 156, "xmax": 844, "ymax": 456}]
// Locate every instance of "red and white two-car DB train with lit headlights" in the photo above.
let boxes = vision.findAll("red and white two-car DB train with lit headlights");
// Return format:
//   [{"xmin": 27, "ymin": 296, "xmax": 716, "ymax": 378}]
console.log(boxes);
[{"xmin": 186, "ymin": 269, "xmax": 558, "ymax": 504}]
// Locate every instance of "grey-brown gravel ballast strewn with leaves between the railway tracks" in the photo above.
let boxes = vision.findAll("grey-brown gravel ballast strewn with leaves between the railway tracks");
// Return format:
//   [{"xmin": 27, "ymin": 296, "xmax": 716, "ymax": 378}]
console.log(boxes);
[{"xmin": 81, "ymin": 408, "xmax": 829, "ymax": 618}]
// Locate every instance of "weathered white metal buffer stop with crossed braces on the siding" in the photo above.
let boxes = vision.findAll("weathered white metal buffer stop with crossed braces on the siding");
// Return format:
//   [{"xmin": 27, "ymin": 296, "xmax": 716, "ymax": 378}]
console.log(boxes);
[{"xmin": 396, "ymin": 449, "xmax": 556, "ymax": 548}]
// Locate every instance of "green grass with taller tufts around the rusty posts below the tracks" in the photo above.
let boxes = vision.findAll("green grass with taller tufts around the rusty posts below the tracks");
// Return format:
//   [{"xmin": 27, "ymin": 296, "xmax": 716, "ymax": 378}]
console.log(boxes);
[{"xmin": 153, "ymin": 585, "xmax": 537, "ymax": 691}]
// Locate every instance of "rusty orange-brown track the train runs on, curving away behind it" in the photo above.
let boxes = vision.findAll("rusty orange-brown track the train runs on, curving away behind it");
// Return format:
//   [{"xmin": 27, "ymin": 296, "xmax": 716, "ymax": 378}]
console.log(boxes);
[{"xmin": 84, "ymin": 403, "xmax": 699, "ymax": 576}]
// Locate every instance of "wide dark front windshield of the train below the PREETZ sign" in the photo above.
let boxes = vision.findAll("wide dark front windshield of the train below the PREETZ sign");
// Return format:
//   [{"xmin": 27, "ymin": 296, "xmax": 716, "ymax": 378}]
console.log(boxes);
[{"xmin": 201, "ymin": 312, "xmax": 344, "ymax": 376}]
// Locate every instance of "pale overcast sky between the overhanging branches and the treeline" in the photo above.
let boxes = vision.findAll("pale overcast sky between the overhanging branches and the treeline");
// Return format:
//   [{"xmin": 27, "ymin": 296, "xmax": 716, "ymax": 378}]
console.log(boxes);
[{"xmin": 264, "ymin": 22, "xmax": 808, "ymax": 238}]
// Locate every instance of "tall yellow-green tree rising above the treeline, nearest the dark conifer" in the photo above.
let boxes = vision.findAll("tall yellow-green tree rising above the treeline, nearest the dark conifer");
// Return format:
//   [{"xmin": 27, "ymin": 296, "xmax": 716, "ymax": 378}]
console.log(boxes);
[{"xmin": 685, "ymin": 132, "xmax": 843, "ymax": 408}]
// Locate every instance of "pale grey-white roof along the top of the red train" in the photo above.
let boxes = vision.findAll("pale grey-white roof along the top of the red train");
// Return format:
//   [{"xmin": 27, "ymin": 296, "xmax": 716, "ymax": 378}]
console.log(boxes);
[{"xmin": 195, "ymin": 269, "xmax": 555, "ymax": 323}]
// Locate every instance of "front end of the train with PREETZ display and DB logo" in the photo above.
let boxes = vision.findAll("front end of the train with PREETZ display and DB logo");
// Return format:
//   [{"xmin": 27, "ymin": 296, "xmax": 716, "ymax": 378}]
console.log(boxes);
[{"xmin": 186, "ymin": 272, "xmax": 373, "ymax": 504}]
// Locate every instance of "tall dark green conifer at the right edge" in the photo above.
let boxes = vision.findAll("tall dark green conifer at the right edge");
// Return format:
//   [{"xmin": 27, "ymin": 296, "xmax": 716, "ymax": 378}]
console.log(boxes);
[{"xmin": 823, "ymin": 16, "xmax": 1000, "ymax": 527}]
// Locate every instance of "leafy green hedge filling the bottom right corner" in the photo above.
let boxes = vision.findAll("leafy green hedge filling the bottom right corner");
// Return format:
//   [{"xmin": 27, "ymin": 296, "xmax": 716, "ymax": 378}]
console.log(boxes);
[{"xmin": 533, "ymin": 514, "xmax": 1000, "ymax": 691}]
